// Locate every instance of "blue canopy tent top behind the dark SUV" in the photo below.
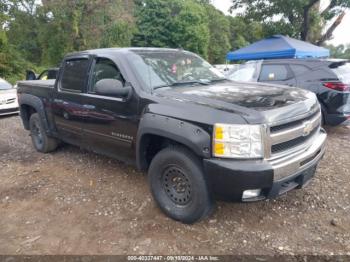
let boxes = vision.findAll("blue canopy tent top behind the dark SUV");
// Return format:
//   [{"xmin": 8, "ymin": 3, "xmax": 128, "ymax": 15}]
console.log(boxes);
[{"xmin": 226, "ymin": 35, "xmax": 330, "ymax": 61}]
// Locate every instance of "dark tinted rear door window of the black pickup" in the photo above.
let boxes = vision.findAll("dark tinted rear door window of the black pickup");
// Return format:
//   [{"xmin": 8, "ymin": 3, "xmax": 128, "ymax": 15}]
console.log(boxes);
[{"xmin": 61, "ymin": 59, "xmax": 89, "ymax": 92}]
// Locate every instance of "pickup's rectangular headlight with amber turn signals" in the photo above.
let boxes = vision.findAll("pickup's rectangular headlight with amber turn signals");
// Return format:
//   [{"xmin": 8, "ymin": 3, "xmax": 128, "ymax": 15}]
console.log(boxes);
[{"xmin": 213, "ymin": 124, "xmax": 264, "ymax": 158}]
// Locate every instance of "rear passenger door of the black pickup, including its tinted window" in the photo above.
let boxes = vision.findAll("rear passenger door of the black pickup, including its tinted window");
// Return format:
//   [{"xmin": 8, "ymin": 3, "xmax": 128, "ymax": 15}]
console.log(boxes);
[{"xmin": 52, "ymin": 56, "xmax": 91, "ymax": 144}]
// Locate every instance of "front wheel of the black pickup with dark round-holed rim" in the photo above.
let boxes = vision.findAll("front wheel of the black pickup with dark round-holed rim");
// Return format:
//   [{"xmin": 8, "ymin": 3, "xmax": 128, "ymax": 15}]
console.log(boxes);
[{"xmin": 148, "ymin": 146, "xmax": 214, "ymax": 224}]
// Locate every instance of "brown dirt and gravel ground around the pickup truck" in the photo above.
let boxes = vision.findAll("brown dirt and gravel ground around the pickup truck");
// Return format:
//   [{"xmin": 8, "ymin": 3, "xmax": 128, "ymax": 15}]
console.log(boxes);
[{"xmin": 0, "ymin": 116, "xmax": 350, "ymax": 255}]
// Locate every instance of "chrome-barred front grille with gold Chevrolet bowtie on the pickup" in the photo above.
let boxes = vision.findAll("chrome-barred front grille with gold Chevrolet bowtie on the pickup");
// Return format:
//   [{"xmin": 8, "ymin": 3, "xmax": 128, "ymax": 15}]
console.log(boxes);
[{"xmin": 267, "ymin": 110, "xmax": 322, "ymax": 159}]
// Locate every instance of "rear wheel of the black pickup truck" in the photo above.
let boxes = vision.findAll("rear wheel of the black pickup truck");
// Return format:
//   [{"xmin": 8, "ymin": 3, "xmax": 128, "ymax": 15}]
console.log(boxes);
[{"xmin": 29, "ymin": 113, "xmax": 58, "ymax": 153}]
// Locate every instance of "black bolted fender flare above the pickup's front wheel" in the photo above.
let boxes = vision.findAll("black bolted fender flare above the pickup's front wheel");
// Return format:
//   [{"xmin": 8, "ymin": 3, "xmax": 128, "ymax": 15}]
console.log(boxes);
[{"xmin": 136, "ymin": 113, "xmax": 211, "ymax": 169}]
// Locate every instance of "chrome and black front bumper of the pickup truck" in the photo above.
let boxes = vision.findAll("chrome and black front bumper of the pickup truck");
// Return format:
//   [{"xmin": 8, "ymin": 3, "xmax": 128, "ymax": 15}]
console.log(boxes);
[{"xmin": 203, "ymin": 128, "xmax": 327, "ymax": 202}]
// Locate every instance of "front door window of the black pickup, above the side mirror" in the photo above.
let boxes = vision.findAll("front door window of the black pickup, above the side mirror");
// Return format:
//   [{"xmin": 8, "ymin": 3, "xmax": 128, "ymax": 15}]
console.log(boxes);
[{"xmin": 90, "ymin": 58, "xmax": 125, "ymax": 92}]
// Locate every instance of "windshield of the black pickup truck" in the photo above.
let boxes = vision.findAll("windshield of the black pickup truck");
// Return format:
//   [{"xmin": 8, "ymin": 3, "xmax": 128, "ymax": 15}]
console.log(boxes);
[{"xmin": 129, "ymin": 50, "xmax": 225, "ymax": 90}]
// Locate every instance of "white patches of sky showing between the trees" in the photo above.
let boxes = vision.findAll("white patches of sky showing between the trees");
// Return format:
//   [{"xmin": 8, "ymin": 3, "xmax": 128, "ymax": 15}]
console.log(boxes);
[{"xmin": 212, "ymin": 0, "xmax": 350, "ymax": 45}]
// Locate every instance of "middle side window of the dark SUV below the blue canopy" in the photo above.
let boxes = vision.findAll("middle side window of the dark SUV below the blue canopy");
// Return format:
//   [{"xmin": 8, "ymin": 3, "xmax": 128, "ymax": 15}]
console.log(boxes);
[{"xmin": 258, "ymin": 63, "xmax": 297, "ymax": 86}]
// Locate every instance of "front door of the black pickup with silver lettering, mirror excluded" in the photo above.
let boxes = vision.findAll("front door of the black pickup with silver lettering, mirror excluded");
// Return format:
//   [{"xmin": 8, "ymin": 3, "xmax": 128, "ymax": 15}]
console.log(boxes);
[{"xmin": 82, "ymin": 57, "xmax": 138, "ymax": 162}]
